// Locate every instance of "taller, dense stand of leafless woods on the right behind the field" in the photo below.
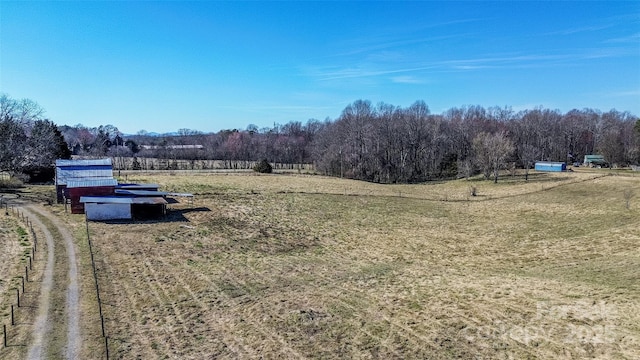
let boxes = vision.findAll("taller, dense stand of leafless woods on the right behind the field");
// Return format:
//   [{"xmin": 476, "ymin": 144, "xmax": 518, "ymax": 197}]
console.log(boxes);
[{"xmin": 312, "ymin": 100, "xmax": 640, "ymax": 183}]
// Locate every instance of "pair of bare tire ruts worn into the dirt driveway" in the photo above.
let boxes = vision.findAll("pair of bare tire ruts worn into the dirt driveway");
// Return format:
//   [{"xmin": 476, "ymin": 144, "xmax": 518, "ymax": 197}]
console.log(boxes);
[{"xmin": 24, "ymin": 205, "xmax": 82, "ymax": 359}]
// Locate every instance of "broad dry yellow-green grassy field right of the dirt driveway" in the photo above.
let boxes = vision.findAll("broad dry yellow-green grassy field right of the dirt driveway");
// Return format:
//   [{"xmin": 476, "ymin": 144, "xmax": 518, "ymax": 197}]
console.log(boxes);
[{"xmin": 53, "ymin": 172, "xmax": 640, "ymax": 359}]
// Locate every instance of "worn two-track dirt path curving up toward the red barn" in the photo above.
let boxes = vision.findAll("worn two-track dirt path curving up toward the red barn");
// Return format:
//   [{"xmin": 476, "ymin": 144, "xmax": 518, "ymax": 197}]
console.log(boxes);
[{"xmin": 23, "ymin": 205, "xmax": 82, "ymax": 360}]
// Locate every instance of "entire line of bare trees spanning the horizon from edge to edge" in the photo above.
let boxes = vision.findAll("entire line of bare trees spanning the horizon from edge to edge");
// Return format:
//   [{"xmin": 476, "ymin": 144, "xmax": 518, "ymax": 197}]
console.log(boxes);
[{"xmin": 0, "ymin": 95, "xmax": 640, "ymax": 183}]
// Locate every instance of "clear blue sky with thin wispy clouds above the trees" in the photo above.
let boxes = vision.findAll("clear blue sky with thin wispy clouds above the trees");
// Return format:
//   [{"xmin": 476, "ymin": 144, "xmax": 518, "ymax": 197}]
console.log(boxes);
[{"xmin": 0, "ymin": 1, "xmax": 640, "ymax": 133}]
